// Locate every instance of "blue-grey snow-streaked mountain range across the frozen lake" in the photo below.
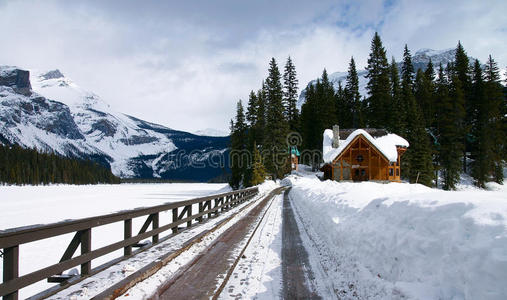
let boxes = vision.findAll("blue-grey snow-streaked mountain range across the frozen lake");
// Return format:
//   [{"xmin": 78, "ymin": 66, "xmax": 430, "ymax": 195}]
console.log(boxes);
[{"xmin": 0, "ymin": 66, "xmax": 228, "ymax": 181}]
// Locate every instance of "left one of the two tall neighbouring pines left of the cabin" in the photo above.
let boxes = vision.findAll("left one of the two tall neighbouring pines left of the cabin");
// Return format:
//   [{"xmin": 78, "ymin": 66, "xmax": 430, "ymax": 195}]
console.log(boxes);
[{"xmin": 263, "ymin": 58, "xmax": 288, "ymax": 178}]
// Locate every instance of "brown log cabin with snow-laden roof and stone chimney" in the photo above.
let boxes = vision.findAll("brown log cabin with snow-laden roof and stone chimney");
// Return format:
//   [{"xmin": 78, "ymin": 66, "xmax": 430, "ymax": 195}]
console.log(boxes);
[{"xmin": 321, "ymin": 125, "xmax": 409, "ymax": 182}]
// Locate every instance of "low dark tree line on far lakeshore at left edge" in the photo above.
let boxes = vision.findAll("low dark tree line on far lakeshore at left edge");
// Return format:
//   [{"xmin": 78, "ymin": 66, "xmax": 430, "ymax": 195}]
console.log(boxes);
[{"xmin": 0, "ymin": 145, "xmax": 120, "ymax": 185}]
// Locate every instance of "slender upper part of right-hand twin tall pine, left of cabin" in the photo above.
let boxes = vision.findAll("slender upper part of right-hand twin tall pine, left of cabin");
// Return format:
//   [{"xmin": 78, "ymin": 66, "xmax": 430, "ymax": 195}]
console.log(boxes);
[{"xmin": 283, "ymin": 56, "xmax": 299, "ymax": 131}]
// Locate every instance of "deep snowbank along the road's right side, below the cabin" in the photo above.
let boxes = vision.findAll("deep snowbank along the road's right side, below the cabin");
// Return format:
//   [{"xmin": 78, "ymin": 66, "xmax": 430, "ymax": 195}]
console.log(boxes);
[{"xmin": 284, "ymin": 175, "xmax": 507, "ymax": 299}]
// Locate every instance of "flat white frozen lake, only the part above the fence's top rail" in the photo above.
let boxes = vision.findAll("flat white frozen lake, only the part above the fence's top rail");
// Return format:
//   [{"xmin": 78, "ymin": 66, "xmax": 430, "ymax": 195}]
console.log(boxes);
[{"xmin": 0, "ymin": 183, "xmax": 229, "ymax": 230}]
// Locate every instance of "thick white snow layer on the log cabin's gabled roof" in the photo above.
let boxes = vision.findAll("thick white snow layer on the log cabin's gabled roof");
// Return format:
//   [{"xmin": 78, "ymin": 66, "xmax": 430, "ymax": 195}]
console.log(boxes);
[{"xmin": 322, "ymin": 129, "xmax": 409, "ymax": 163}]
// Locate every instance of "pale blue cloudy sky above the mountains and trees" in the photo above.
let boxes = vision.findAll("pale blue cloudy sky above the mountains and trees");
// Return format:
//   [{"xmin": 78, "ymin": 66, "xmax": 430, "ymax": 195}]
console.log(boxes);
[{"xmin": 0, "ymin": 0, "xmax": 507, "ymax": 132}]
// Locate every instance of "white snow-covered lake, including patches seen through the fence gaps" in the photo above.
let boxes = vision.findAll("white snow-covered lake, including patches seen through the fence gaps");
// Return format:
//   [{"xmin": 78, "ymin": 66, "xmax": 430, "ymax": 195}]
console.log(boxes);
[{"xmin": 0, "ymin": 183, "xmax": 230, "ymax": 298}]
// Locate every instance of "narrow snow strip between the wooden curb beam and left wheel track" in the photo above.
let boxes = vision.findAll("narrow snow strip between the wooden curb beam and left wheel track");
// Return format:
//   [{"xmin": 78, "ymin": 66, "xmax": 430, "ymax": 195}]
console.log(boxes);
[{"xmin": 118, "ymin": 181, "xmax": 278, "ymax": 299}]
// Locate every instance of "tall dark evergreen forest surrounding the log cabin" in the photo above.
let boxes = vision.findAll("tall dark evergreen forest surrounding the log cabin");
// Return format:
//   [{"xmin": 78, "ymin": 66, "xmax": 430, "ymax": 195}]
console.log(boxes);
[{"xmin": 231, "ymin": 33, "xmax": 507, "ymax": 189}]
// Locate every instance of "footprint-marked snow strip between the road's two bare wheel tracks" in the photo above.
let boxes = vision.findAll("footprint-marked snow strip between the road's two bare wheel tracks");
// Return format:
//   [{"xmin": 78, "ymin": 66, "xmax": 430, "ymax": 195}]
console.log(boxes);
[{"xmin": 219, "ymin": 194, "xmax": 283, "ymax": 299}]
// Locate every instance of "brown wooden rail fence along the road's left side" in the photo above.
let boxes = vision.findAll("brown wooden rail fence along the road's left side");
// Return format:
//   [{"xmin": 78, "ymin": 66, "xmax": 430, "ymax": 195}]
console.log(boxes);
[{"xmin": 0, "ymin": 187, "xmax": 259, "ymax": 300}]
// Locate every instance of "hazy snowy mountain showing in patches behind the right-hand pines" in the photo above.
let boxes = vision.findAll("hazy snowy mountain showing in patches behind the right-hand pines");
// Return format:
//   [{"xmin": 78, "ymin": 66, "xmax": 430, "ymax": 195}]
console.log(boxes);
[{"xmin": 298, "ymin": 48, "xmax": 456, "ymax": 109}]
